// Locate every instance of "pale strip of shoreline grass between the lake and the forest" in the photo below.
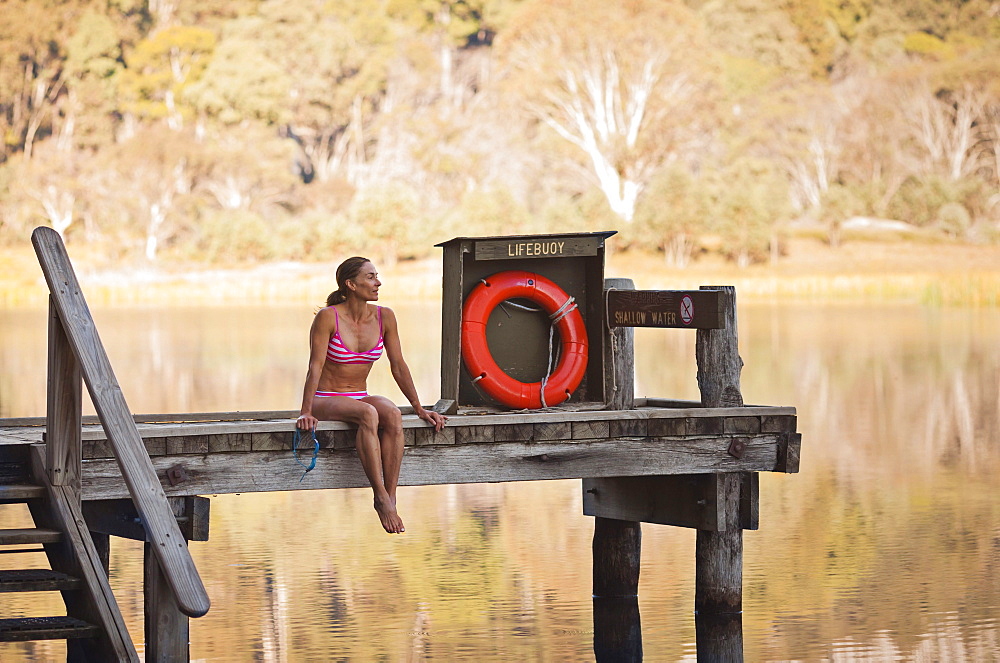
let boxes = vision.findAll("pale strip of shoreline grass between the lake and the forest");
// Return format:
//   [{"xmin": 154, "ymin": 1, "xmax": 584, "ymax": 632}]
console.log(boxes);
[{"xmin": 0, "ymin": 243, "xmax": 1000, "ymax": 309}]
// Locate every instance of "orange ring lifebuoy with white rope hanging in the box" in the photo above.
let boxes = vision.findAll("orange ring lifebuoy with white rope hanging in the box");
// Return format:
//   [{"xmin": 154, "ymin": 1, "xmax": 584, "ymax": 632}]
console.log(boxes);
[{"xmin": 462, "ymin": 270, "xmax": 587, "ymax": 409}]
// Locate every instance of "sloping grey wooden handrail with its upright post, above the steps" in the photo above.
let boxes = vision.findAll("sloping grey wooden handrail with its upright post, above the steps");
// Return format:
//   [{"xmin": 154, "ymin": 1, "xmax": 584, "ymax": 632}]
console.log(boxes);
[{"xmin": 31, "ymin": 227, "xmax": 210, "ymax": 617}]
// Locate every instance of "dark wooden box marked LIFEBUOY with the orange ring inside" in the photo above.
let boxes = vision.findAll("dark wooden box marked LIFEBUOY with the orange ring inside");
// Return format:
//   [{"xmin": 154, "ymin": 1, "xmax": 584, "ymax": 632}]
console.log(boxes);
[{"xmin": 437, "ymin": 231, "xmax": 615, "ymax": 409}]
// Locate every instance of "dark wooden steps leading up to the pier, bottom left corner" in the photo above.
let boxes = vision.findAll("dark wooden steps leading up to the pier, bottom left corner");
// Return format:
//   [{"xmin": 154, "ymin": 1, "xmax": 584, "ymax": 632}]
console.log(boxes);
[{"xmin": 0, "ymin": 444, "xmax": 139, "ymax": 661}]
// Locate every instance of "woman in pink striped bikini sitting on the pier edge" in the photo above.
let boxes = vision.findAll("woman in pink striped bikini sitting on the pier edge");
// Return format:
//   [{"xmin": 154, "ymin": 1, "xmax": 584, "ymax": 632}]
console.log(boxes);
[{"xmin": 295, "ymin": 257, "xmax": 445, "ymax": 534}]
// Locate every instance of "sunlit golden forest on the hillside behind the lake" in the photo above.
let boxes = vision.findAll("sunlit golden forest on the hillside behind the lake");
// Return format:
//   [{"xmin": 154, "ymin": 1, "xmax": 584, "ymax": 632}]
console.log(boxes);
[{"xmin": 0, "ymin": 0, "xmax": 1000, "ymax": 304}]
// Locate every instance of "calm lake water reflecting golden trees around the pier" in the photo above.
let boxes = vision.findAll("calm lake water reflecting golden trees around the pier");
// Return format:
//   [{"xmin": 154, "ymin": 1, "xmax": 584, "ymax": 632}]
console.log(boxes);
[{"xmin": 0, "ymin": 302, "xmax": 1000, "ymax": 661}]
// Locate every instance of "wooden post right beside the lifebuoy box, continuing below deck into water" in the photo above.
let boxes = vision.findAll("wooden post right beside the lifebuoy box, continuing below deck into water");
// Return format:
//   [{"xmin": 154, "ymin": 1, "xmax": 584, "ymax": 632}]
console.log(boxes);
[{"xmin": 593, "ymin": 279, "xmax": 642, "ymax": 662}]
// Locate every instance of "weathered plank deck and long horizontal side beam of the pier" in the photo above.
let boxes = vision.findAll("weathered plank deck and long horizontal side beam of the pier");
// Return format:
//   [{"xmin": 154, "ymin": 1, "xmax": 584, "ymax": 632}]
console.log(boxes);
[{"xmin": 0, "ymin": 401, "xmax": 801, "ymax": 500}]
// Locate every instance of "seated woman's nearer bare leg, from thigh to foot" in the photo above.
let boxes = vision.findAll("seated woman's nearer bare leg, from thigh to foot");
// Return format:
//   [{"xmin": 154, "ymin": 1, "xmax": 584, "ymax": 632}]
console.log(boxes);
[{"xmin": 313, "ymin": 396, "xmax": 405, "ymax": 534}]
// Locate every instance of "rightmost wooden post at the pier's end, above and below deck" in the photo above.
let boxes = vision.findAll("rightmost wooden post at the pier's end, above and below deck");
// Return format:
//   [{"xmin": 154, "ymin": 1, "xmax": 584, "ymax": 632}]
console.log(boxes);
[{"xmin": 694, "ymin": 286, "xmax": 743, "ymax": 615}]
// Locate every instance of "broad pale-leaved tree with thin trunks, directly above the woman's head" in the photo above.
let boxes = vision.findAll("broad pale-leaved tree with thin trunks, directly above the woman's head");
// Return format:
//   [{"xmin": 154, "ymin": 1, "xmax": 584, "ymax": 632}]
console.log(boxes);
[{"xmin": 205, "ymin": 0, "xmax": 396, "ymax": 181}]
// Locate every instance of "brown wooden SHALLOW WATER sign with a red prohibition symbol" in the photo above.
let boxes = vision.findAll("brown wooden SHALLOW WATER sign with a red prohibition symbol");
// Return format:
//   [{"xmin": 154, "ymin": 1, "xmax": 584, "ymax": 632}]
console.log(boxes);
[{"xmin": 607, "ymin": 290, "xmax": 723, "ymax": 329}]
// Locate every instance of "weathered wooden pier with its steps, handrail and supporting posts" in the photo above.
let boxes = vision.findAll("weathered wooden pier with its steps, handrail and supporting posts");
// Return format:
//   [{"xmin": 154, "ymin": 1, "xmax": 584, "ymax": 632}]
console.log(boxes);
[{"xmin": 0, "ymin": 228, "xmax": 801, "ymax": 661}]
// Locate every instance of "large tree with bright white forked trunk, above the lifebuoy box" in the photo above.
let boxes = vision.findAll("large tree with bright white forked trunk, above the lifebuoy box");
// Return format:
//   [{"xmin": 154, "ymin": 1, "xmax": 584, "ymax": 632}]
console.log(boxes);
[{"xmin": 502, "ymin": 0, "xmax": 711, "ymax": 223}]
